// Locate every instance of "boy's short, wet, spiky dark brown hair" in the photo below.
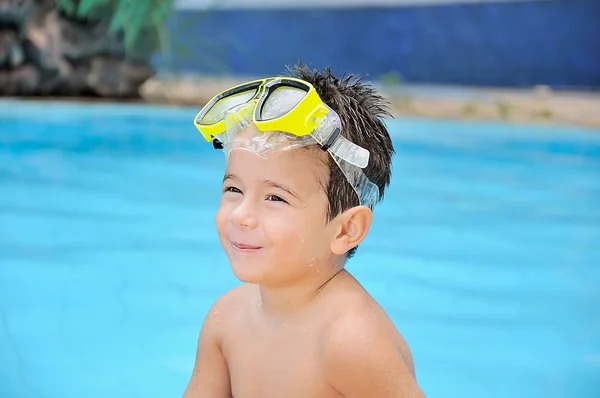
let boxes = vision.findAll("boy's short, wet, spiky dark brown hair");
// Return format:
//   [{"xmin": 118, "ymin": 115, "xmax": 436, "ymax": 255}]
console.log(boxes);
[{"xmin": 287, "ymin": 62, "xmax": 394, "ymax": 259}]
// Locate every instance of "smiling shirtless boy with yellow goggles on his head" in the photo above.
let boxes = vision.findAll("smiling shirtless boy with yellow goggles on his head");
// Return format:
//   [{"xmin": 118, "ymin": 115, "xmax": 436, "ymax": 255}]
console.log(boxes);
[{"xmin": 183, "ymin": 64, "xmax": 424, "ymax": 398}]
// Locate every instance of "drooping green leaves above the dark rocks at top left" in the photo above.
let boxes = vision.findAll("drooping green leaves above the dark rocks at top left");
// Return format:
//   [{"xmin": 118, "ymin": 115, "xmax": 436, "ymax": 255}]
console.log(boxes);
[{"xmin": 57, "ymin": 0, "xmax": 174, "ymax": 50}]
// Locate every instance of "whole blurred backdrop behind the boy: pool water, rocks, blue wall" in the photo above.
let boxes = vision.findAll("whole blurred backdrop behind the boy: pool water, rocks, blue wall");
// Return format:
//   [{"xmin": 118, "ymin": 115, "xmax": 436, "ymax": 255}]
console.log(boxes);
[{"xmin": 0, "ymin": 0, "xmax": 600, "ymax": 398}]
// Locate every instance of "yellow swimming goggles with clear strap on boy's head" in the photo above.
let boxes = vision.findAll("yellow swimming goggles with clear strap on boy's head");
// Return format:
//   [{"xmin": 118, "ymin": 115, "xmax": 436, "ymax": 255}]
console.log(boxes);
[{"xmin": 194, "ymin": 76, "xmax": 379, "ymax": 209}]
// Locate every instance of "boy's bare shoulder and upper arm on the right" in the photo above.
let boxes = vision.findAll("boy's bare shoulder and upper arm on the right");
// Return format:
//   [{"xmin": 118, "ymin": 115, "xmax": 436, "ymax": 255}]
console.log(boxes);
[{"xmin": 322, "ymin": 291, "xmax": 425, "ymax": 398}]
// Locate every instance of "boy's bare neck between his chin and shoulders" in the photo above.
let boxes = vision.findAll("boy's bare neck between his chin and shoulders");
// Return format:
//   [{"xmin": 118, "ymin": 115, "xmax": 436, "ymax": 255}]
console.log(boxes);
[{"xmin": 259, "ymin": 267, "xmax": 346, "ymax": 317}]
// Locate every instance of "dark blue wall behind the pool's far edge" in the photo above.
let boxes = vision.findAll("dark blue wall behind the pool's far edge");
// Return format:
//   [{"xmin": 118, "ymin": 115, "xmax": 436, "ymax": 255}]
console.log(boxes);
[{"xmin": 158, "ymin": 0, "xmax": 600, "ymax": 88}]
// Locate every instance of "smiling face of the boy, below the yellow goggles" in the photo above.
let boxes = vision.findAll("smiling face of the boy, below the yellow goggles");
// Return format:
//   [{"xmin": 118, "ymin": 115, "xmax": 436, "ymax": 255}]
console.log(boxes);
[{"xmin": 215, "ymin": 148, "xmax": 335, "ymax": 286}]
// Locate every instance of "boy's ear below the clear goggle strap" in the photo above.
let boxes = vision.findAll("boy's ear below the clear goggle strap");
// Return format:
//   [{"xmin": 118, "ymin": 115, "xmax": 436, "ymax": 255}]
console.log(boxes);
[{"xmin": 331, "ymin": 206, "xmax": 373, "ymax": 255}]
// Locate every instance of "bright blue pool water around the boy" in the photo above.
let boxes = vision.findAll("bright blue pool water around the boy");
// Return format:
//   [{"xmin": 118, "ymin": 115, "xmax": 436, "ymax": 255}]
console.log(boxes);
[{"xmin": 0, "ymin": 101, "xmax": 600, "ymax": 398}]
